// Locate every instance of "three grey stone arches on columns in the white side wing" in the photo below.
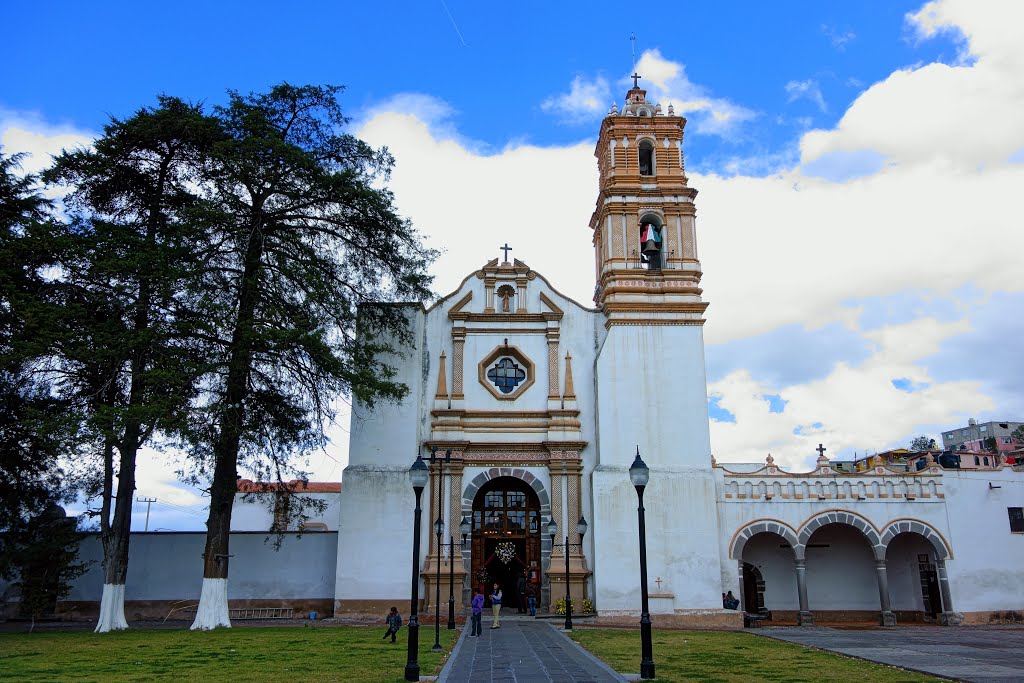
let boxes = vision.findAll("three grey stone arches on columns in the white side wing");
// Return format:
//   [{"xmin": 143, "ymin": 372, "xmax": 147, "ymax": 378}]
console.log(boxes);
[{"xmin": 729, "ymin": 509, "xmax": 953, "ymax": 625}]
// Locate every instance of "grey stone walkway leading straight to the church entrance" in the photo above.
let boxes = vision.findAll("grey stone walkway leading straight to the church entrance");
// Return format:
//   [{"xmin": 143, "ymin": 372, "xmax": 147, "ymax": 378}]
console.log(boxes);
[{"xmin": 437, "ymin": 614, "xmax": 628, "ymax": 683}]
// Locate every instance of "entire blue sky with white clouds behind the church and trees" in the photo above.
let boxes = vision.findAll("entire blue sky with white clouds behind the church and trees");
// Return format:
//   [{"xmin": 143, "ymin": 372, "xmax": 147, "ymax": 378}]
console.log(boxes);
[{"xmin": 0, "ymin": 0, "xmax": 1024, "ymax": 528}]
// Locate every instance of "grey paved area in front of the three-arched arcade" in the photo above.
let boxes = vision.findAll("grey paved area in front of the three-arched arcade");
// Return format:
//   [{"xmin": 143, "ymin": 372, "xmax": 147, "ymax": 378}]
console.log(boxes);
[{"xmin": 761, "ymin": 626, "xmax": 1024, "ymax": 683}]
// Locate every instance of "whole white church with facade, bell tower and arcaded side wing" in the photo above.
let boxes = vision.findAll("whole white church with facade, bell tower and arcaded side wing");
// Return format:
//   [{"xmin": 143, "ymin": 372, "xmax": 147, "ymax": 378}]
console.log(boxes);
[{"xmin": 335, "ymin": 82, "xmax": 1024, "ymax": 628}]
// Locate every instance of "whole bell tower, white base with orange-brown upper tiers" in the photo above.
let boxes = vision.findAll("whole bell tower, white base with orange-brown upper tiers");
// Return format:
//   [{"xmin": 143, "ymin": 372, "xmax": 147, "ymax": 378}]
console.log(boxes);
[{"xmin": 590, "ymin": 75, "xmax": 727, "ymax": 625}]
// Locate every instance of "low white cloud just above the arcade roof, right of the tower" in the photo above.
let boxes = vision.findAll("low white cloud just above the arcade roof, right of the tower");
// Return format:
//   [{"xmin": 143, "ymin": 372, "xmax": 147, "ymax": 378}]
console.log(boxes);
[{"xmin": 708, "ymin": 318, "xmax": 993, "ymax": 470}]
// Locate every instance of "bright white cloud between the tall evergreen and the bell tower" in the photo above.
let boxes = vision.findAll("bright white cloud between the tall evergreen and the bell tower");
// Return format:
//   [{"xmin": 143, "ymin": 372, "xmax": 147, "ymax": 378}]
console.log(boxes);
[{"xmin": 356, "ymin": 107, "xmax": 597, "ymax": 305}]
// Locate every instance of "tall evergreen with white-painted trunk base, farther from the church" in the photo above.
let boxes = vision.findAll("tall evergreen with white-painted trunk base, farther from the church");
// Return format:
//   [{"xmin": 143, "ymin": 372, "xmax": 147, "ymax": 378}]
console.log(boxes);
[{"xmin": 44, "ymin": 97, "xmax": 218, "ymax": 632}]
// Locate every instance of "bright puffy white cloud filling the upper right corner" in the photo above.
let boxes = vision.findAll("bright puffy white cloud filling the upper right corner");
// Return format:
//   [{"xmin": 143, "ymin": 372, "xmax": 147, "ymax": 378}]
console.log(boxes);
[{"xmin": 801, "ymin": 0, "xmax": 1024, "ymax": 168}]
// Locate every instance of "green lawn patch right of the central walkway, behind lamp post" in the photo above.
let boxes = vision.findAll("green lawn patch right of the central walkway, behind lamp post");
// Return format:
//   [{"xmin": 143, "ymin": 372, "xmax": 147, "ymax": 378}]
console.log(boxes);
[{"xmin": 571, "ymin": 629, "xmax": 941, "ymax": 683}]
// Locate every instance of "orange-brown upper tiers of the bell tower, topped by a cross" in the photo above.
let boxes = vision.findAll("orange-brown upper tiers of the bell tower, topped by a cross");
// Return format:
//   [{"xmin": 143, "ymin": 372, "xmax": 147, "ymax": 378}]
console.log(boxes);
[{"xmin": 590, "ymin": 76, "xmax": 708, "ymax": 327}]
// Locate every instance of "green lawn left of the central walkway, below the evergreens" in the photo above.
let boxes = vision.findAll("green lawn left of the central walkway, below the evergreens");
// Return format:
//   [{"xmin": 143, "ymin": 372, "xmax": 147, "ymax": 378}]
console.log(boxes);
[{"xmin": 0, "ymin": 625, "xmax": 458, "ymax": 683}]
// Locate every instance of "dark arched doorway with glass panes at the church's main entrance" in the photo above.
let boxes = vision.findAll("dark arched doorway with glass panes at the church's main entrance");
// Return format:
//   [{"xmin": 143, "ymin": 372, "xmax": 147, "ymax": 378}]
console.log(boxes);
[{"xmin": 471, "ymin": 476, "xmax": 542, "ymax": 607}]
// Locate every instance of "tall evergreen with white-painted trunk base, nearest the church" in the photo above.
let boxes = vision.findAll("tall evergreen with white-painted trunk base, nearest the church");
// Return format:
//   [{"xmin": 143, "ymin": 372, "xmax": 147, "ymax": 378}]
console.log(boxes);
[{"xmin": 193, "ymin": 83, "xmax": 435, "ymax": 629}]
